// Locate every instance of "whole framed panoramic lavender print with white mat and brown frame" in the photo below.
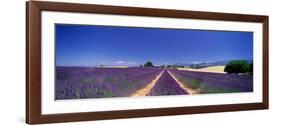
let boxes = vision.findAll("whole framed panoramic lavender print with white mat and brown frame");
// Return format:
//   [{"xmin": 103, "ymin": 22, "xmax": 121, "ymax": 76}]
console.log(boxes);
[{"xmin": 26, "ymin": 1, "xmax": 268, "ymax": 124}]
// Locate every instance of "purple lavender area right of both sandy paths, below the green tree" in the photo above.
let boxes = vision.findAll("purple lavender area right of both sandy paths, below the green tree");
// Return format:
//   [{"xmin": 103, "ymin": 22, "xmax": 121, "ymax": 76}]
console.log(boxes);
[{"xmin": 169, "ymin": 69, "xmax": 253, "ymax": 94}]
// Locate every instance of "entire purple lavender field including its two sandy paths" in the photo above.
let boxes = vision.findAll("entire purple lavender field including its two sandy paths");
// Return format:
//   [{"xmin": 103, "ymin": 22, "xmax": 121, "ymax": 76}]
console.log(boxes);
[{"xmin": 55, "ymin": 67, "xmax": 253, "ymax": 100}]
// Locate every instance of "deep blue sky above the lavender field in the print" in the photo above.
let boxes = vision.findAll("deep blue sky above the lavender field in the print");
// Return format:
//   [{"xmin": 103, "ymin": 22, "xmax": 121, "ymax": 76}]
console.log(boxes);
[{"xmin": 55, "ymin": 24, "xmax": 253, "ymax": 66}]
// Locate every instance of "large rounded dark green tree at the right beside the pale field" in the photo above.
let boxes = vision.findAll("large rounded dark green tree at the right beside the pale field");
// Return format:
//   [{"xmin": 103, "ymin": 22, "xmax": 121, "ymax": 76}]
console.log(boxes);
[{"xmin": 224, "ymin": 60, "xmax": 249, "ymax": 74}]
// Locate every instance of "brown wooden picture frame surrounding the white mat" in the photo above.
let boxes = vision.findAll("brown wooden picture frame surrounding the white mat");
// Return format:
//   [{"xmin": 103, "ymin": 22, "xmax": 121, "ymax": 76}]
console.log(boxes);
[{"xmin": 26, "ymin": 1, "xmax": 269, "ymax": 124}]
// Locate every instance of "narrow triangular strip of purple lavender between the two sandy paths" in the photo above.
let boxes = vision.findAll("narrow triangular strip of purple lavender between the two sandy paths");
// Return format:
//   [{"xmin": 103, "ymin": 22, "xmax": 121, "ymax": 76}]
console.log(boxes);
[{"xmin": 148, "ymin": 70, "xmax": 188, "ymax": 96}]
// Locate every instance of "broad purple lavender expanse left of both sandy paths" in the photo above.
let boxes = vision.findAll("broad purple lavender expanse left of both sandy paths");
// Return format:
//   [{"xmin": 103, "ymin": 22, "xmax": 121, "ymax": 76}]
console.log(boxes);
[{"xmin": 55, "ymin": 67, "xmax": 162, "ymax": 99}]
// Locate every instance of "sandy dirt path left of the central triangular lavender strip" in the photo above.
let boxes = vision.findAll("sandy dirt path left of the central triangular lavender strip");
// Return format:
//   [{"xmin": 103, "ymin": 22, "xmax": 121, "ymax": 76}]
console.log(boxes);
[{"xmin": 131, "ymin": 70, "xmax": 164, "ymax": 97}]
